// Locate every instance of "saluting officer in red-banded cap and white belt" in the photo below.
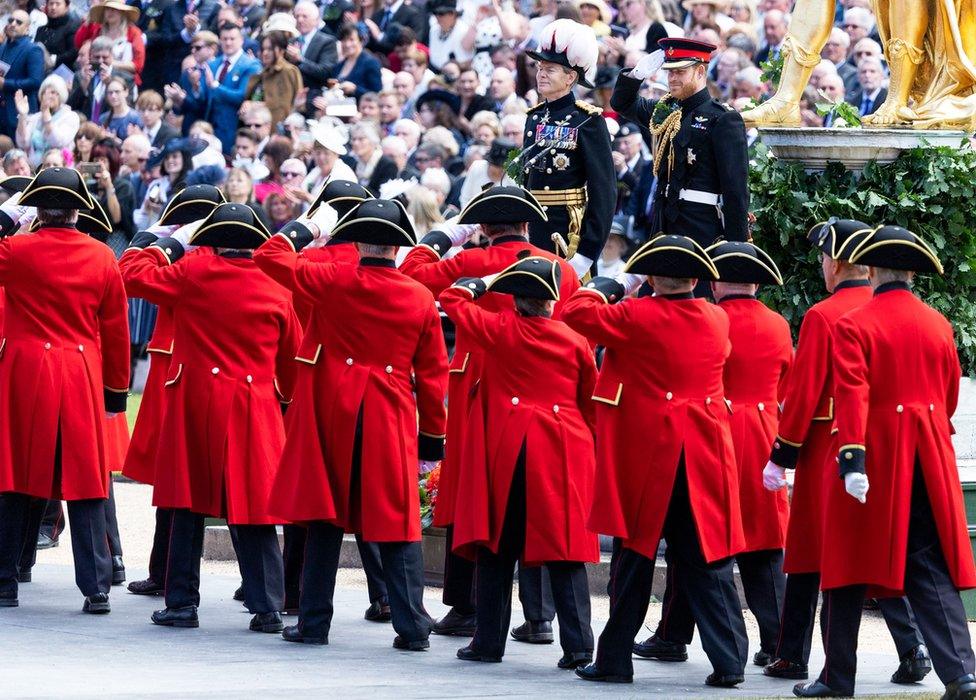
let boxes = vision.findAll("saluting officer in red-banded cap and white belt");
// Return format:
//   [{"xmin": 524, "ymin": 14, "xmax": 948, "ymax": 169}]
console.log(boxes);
[{"xmin": 610, "ymin": 39, "xmax": 749, "ymax": 246}]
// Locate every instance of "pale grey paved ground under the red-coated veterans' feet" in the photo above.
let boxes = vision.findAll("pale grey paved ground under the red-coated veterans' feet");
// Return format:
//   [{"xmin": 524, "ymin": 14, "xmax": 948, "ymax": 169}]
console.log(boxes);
[{"xmin": 0, "ymin": 484, "xmax": 941, "ymax": 699}]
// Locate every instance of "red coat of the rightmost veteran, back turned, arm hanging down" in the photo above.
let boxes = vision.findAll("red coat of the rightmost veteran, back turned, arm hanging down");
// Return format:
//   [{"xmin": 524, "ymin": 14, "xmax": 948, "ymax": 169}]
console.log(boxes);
[{"xmin": 820, "ymin": 289, "xmax": 976, "ymax": 595}]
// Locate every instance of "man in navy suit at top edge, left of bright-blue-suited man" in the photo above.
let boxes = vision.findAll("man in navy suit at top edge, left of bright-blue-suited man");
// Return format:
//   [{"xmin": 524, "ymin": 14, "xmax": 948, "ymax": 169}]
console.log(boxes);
[{"xmin": 146, "ymin": 0, "xmax": 219, "ymax": 89}]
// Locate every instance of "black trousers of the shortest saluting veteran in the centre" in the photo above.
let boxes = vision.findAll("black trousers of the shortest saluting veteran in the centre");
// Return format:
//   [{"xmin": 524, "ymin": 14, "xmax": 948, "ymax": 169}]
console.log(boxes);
[{"xmin": 471, "ymin": 447, "xmax": 593, "ymax": 657}]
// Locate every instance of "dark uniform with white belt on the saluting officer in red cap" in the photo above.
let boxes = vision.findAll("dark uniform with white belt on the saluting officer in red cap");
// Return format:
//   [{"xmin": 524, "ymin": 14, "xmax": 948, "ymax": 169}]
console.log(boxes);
[{"xmin": 610, "ymin": 73, "xmax": 749, "ymax": 246}]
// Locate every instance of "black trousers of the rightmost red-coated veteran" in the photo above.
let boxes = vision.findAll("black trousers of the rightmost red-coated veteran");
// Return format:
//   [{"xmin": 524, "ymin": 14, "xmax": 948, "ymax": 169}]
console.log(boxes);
[{"xmin": 820, "ymin": 464, "xmax": 976, "ymax": 695}]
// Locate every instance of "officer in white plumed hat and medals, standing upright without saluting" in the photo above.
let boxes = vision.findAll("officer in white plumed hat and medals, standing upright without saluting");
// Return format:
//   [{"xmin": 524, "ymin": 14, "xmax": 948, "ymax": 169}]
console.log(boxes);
[{"xmin": 518, "ymin": 19, "xmax": 617, "ymax": 277}]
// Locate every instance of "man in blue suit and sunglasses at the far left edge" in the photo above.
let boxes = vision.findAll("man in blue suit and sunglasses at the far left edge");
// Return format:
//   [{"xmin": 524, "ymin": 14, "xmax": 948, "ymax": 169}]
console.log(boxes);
[{"xmin": 0, "ymin": 10, "xmax": 44, "ymax": 138}]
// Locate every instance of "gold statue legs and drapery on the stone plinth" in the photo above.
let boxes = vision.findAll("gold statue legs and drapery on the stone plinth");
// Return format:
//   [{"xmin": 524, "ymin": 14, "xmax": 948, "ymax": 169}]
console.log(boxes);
[{"xmin": 742, "ymin": 0, "xmax": 976, "ymax": 131}]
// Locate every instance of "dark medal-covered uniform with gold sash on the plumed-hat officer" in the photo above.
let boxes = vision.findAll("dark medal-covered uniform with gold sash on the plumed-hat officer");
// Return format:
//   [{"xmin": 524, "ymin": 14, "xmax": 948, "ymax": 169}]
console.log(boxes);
[{"xmin": 519, "ymin": 92, "xmax": 617, "ymax": 260}]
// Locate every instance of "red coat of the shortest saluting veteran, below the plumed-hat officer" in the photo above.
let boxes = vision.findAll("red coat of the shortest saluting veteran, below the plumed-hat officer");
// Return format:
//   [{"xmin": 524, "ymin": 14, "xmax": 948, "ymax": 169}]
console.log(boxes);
[{"xmin": 438, "ymin": 287, "xmax": 600, "ymax": 563}]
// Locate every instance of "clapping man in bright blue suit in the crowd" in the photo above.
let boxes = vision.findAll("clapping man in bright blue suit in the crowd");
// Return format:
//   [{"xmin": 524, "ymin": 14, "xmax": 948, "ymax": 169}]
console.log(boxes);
[{"xmin": 180, "ymin": 23, "xmax": 261, "ymax": 155}]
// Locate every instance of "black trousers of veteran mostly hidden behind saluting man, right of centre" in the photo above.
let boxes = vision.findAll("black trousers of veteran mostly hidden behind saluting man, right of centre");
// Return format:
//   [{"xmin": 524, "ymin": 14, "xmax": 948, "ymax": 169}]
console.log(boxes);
[{"xmin": 655, "ymin": 549, "xmax": 786, "ymax": 654}]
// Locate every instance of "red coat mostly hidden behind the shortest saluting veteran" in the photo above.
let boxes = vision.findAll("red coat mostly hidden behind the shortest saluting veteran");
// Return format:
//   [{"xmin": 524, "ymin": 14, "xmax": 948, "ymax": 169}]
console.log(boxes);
[{"xmin": 400, "ymin": 236, "xmax": 579, "ymax": 526}]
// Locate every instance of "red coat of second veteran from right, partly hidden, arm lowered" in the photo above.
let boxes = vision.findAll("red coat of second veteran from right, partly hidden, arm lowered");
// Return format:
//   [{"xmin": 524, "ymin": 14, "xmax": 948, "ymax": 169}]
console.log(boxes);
[{"xmin": 777, "ymin": 280, "xmax": 871, "ymax": 574}]
